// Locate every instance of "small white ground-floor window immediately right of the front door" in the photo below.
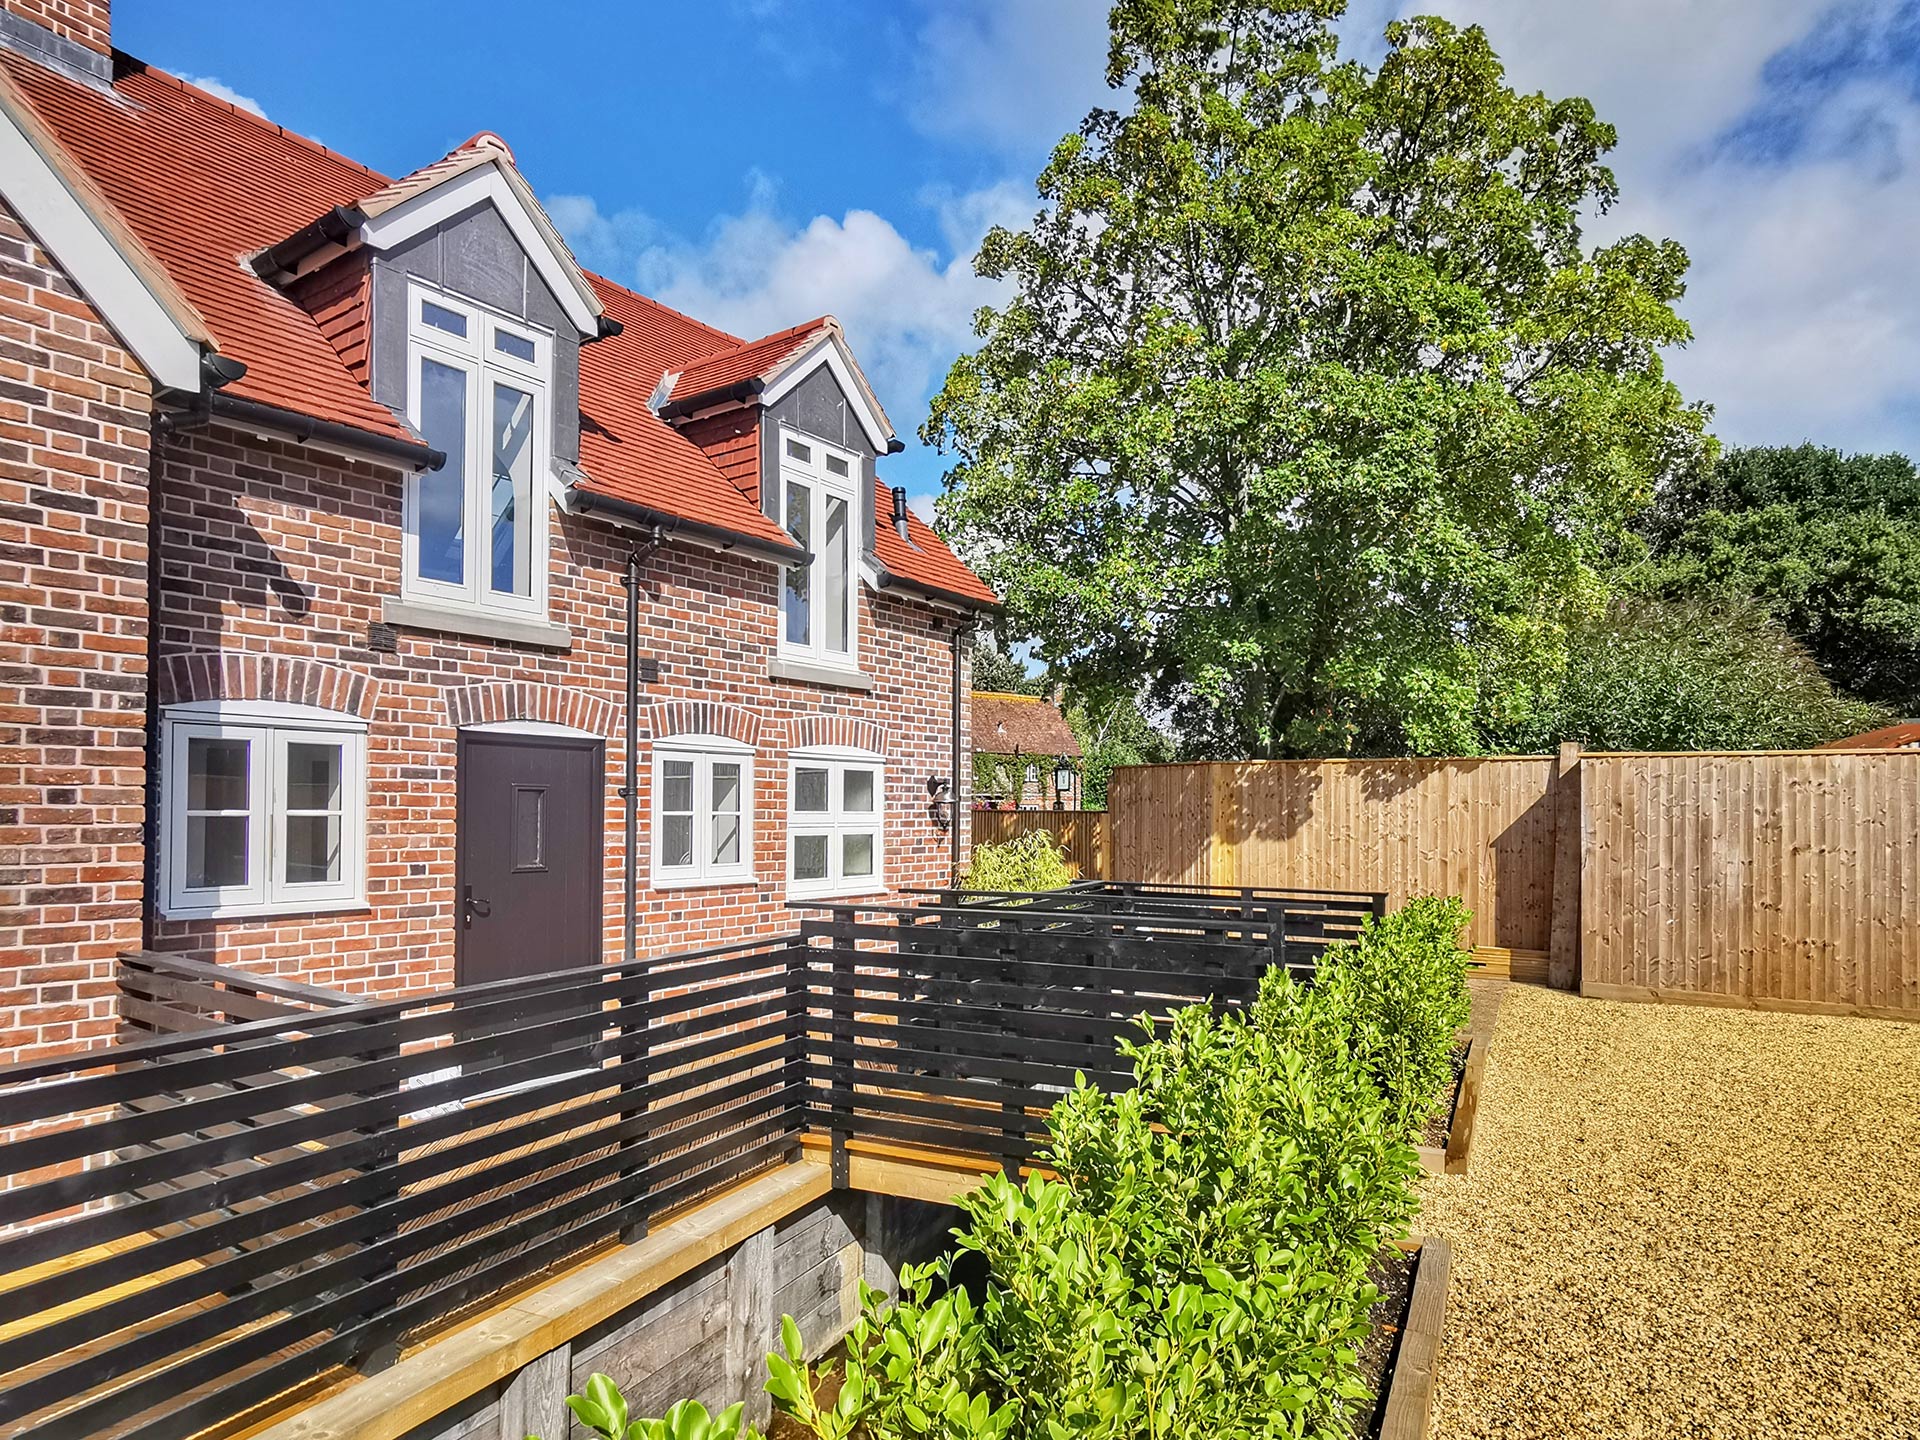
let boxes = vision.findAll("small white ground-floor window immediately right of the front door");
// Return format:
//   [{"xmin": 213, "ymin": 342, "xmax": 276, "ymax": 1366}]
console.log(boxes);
[{"xmin": 653, "ymin": 735, "xmax": 753, "ymax": 887}]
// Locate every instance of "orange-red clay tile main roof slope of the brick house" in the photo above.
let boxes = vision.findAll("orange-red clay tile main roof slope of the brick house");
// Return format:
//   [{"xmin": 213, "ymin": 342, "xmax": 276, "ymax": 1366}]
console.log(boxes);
[{"xmin": 0, "ymin": 52, "xmax": 995, "ymax": 603}]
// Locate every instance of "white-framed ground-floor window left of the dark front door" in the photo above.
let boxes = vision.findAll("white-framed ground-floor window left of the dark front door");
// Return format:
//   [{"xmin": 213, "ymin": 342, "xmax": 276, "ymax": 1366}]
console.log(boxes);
[{"xmin": 161, "ymin": 701, "xmax": 367, "ymax": 918}]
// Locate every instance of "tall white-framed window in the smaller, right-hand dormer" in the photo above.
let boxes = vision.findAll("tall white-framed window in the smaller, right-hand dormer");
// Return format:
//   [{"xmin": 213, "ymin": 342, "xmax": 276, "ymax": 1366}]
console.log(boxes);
[{"xmin": 780, "ymin": 428, "xmax": 860, "ymax": 670}]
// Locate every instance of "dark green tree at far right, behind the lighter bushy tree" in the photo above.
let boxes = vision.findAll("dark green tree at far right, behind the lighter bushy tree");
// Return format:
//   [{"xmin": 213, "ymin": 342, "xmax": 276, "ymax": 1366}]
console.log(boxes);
[{"xmin": 1634, "ymin": 445, "xmax": 1920, "ymax": 714}]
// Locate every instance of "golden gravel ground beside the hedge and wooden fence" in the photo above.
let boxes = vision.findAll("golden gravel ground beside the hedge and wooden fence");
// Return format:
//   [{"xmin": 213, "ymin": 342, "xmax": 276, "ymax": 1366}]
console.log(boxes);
[{"xmin": 1421, "ymin": 985, "xmax": 1920, "ymax": 1440}]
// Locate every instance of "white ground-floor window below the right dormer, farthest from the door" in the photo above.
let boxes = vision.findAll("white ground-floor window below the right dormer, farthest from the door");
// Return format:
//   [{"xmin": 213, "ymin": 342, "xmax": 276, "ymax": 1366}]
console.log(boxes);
[{"xmin": 787, "ymin": 747, "xmax": 887, "ymax": 899}]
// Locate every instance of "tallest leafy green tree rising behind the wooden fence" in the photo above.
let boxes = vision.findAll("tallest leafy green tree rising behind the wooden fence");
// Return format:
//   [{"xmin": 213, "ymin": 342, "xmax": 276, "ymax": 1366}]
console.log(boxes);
[{"xmin": 924, "ymin": 0, "xmax": 1707, "ymax": 755}]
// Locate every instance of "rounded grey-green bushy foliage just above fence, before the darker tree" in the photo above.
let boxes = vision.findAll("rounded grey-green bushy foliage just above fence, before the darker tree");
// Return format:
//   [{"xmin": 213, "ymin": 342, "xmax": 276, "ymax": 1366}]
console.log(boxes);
[{"xmin": 1486, "ymin": 595, "xmax": 1889, "ymax": 751}]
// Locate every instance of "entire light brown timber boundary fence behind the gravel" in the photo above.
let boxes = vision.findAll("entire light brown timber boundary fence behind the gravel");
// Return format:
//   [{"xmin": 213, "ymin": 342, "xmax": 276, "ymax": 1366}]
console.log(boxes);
[{"xmin": 1105, "ymin": 745, "xmax": 1920, "ymax": 1020}]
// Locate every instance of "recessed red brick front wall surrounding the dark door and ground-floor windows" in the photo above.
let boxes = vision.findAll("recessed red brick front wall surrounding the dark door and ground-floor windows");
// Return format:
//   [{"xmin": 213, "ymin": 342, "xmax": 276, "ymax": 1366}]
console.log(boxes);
[{"xmin": 145, "ymin": 426, "xmax": 966, "ymax": 993}]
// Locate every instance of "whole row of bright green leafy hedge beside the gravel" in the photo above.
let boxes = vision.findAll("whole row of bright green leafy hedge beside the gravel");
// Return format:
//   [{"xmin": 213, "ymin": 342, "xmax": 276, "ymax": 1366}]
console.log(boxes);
[{"xmin": 556, "ymin": 899, "xmax": 1467, "ymax": 1440}]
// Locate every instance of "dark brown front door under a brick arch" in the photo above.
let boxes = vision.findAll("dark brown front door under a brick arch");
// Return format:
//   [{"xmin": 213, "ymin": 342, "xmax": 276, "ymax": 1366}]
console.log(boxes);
[{"xmin": 453, "ymin": 730, "xmax": 605, "ymax": 985}]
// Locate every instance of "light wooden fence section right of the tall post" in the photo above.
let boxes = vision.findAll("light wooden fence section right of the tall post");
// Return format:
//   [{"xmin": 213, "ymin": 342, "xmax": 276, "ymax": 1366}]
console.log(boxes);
[{"xmin": 1580, "ymin": 751, "xmax": 1920, "ymax": 1018}]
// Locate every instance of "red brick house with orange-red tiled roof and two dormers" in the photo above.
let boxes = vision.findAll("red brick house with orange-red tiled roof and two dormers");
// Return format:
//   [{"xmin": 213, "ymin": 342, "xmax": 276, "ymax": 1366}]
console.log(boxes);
[{"xmin": 0, "ymin": 0, "xmax": 995, "ymax": 1056}]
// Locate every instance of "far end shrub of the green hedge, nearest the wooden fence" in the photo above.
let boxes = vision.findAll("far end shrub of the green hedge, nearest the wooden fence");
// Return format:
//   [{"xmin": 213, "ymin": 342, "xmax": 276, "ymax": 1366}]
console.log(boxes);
[{"xmin": 1313, "ymin": 895, "xmax": 1473, "ymax": 1133}]
